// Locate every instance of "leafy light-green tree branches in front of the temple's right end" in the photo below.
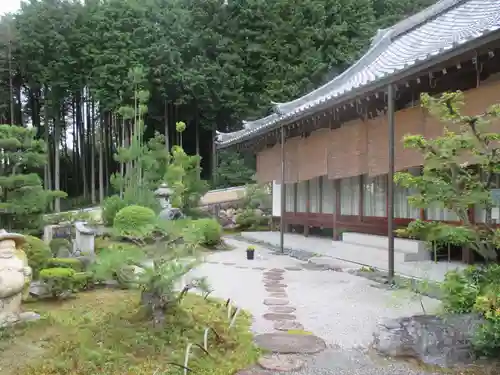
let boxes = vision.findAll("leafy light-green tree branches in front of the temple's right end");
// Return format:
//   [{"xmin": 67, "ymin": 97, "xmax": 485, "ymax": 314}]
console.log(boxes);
[{"xmin": 395, "ymin": 92, "xmax": 500, "ymax": 260}]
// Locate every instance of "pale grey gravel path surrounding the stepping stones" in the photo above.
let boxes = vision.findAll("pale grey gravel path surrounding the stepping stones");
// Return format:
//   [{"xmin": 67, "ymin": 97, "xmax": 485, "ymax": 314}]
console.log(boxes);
[{"xmin": 189, "ymin": 239, "xmax": 439, "ymax": 375}]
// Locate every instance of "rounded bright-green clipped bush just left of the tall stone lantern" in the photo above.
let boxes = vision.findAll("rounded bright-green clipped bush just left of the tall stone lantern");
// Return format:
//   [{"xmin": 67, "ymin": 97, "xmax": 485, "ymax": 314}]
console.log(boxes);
[{"xmin": 113, "ymin": 206, "xmax": 157, "ymax": 238}]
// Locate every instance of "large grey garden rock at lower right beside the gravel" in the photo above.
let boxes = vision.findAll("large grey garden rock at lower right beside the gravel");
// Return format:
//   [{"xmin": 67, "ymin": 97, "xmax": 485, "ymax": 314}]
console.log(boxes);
[{"xmin": 373, "ymin": 314, "xmax": 482, "ymax": 367}]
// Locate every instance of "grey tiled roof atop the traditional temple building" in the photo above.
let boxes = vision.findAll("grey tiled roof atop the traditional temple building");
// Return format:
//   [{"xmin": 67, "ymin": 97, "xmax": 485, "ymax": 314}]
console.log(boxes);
[{"xmin": 217, "ymin": 0, "xmax": 500, "ymax": 147}]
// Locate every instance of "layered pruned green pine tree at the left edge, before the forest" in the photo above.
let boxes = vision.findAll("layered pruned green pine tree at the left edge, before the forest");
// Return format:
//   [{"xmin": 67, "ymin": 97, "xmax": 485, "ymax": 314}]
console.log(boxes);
[{"xmin": 0, "ymin": 125, "xmax": 66, "ymax": 230}]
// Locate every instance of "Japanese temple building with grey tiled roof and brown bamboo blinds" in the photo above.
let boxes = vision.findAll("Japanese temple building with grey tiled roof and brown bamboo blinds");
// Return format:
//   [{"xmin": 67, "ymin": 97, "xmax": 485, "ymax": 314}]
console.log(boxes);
[{"xmin": 216, "ymin": 0, "xmax": 500, "ymax": 262}]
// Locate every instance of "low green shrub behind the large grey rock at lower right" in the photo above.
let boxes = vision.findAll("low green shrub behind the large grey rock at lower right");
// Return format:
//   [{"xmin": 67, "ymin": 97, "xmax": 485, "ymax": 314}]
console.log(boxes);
[{"xmin": 442, "ymin": 264, "xmax": 500, "ymax": 357}]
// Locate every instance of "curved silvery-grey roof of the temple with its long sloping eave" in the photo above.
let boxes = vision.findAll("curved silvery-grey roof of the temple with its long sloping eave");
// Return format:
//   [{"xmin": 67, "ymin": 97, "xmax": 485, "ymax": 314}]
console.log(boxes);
[{"xmin": 217, "ymin": 0, "xmax": 500, "ymax": 148}]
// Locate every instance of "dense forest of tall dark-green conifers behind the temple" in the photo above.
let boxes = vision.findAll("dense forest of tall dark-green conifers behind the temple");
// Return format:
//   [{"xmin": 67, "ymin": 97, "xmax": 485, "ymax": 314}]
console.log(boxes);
[{"xmin": 0, "ymin": 0, "xmax": 435, "ymax": 210}]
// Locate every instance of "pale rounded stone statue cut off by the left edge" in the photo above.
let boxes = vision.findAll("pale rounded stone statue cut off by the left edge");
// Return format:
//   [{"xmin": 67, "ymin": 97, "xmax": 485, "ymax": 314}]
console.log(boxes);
[{"xmin": 0, "ymin": 229, "xmax": 36, "ymax": 327}]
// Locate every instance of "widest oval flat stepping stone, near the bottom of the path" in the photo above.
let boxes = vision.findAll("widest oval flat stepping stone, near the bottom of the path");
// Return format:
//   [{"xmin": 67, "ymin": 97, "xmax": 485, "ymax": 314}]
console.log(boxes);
[{"xmin": 254, "ymin": 332, "xmax": 326, "ymax": 354}]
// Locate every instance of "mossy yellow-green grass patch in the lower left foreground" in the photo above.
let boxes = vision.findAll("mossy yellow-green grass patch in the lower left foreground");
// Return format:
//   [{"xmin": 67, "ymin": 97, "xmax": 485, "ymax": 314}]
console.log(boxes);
[{"xmin": 0, "ymin": 290, "xmax": 258, "ymax": 375}]
